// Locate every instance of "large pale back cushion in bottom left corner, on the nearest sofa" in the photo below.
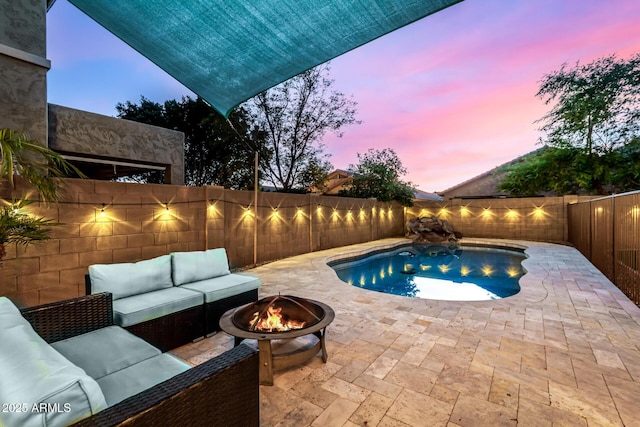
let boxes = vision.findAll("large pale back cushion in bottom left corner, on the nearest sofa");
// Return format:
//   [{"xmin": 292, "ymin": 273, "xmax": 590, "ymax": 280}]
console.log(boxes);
[{"xmin": 0, "ymin": 297, "xmax": 107, "ymax": 427}]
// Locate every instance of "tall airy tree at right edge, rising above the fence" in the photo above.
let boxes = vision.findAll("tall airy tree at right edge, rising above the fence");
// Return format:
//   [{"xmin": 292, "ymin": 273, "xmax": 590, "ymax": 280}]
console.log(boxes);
[{"xmin": 537, "ymin": 54, "xmax": 640, "ymax": 194}]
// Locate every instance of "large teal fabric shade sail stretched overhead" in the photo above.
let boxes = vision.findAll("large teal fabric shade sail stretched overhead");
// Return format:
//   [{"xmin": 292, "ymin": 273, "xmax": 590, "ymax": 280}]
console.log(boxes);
[{"xmin": 69, "ymin": 0, "xmax": 461, "ymax": 117}]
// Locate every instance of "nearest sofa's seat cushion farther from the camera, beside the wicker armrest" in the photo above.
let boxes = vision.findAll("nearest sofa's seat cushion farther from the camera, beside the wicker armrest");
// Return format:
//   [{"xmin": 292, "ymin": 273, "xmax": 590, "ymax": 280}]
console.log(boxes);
[{"xmin": 51, "ymin": 326, "xmax": 162, "ymax": 380}]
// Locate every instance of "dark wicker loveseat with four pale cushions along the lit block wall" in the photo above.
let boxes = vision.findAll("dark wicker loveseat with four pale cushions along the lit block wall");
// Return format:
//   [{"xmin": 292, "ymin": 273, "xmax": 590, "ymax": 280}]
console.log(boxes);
[{"xmin": 86, "ymin": 248, "xmax": 260, "ymax": 351}]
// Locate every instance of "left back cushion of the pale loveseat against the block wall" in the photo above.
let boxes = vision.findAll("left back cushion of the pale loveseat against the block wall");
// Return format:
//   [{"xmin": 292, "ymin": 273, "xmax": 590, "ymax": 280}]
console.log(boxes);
[{"xmin": 89, "ymin": 255, "xmax": 173, "ymax": 300}]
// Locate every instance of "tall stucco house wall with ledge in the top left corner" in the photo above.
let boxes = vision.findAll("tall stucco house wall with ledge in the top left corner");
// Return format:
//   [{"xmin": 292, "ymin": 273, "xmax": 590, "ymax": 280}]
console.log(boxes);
[{"xmin": 0, "ymin": 0, "xmax": 49, "ymax": 144}]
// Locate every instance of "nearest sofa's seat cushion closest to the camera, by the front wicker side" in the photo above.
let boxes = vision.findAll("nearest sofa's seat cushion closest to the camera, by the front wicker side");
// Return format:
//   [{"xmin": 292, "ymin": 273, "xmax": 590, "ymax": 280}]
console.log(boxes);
[{"xmin": 98, "ymin": 353, "xmax": 191, "ymax": 406}]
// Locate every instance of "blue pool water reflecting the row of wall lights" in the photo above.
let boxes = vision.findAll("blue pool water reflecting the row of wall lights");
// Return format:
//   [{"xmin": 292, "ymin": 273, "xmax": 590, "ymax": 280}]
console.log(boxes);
[{"xmin": 330, "ymin": 244, "xmax": 527, "ymax": 301}]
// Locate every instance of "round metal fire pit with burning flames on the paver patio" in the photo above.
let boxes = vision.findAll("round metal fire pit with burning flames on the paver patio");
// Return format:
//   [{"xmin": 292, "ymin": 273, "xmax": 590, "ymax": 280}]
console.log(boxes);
[{"xmin": 220, "ymin": 295, "xmax": 335, "ymax": 385}]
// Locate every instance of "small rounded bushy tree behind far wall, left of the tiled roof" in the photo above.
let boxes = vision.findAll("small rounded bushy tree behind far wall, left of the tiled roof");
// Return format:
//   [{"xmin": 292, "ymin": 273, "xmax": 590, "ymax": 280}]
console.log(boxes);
[{"xmin": 339, "ymin": 148, "xmax": 415, "ymax": 206}]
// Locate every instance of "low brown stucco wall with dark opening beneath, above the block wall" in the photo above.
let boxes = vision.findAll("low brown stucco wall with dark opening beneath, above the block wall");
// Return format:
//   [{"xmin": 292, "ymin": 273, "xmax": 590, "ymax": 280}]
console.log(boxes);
[{"xmin": 49, "ymin": 104, "xmax": 184, "ymax": 185}]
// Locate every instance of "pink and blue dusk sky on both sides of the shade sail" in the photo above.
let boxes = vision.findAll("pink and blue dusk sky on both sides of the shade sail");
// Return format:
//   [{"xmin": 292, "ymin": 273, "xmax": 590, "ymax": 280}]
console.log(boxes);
[{"xmin": 47, "ymin": 0, "xmax": 640, "ymax": 191}]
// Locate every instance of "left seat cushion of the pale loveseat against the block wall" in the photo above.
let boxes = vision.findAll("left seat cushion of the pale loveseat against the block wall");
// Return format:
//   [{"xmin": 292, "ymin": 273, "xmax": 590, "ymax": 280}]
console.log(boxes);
[{"xmin": 113, "ymin": 287, "xmax": 203, "ymax": 327}]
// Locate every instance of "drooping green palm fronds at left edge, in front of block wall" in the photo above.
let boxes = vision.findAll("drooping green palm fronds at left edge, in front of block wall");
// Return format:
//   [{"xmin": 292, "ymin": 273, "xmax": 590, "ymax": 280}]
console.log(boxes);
[{"xmin": 0, "ymin": 129, "xmax": 83, "ymax": 266}]
